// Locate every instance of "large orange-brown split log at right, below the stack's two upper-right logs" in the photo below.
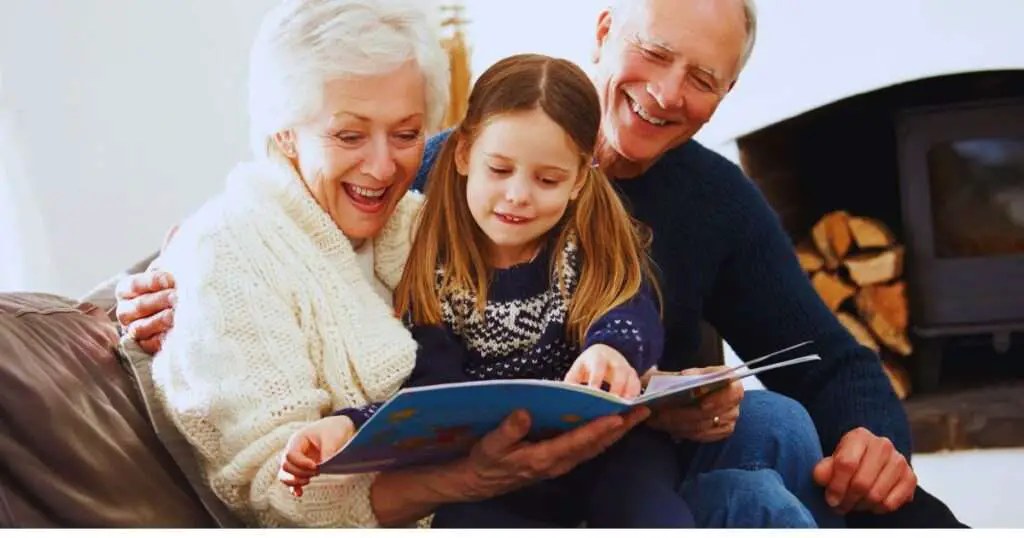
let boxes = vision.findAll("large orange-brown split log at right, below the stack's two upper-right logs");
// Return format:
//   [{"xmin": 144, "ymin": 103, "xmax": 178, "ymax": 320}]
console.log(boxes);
[{"xmin": 854, "ymin": 281, "xmax": 913, "ymax": 357}]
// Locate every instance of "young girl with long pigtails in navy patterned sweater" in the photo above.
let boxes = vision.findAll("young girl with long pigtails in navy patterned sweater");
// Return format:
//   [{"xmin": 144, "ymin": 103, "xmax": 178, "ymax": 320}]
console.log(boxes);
[{"xmin": 286, "ymin": 54, "xmax": 693, "ymax": 528}]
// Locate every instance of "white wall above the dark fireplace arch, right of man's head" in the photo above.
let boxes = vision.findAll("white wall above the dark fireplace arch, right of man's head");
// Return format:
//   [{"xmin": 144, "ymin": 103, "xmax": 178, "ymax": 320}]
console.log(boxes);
[{"xmin": 701, "ymin": 0, "xmax": 1024, "ymax": 143}]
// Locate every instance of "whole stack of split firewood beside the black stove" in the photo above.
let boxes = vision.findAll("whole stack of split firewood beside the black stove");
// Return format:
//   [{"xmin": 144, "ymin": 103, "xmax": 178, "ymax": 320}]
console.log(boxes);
[{"xmin": 797, "ymin": 211, "xmax": 913, "ymax": 399}]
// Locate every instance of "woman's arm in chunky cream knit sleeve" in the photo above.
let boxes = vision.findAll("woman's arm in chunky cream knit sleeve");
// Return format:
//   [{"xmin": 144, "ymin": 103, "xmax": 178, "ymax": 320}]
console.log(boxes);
[{"xmin": 154, "ymin": 230, "xmax": 385, "ymax": 527}]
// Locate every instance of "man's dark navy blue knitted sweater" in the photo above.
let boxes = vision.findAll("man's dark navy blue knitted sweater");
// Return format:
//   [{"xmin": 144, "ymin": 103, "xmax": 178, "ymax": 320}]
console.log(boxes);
[{"xmin": 413, "ymin": 132, "xmax": 910, "ymax": 458}]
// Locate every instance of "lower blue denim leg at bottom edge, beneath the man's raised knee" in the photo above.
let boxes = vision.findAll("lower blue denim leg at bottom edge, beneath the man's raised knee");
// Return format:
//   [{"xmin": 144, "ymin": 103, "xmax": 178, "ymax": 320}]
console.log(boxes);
[{"xmin": 681, "ymin": 469, "xmax": 817, "ymax": 529}]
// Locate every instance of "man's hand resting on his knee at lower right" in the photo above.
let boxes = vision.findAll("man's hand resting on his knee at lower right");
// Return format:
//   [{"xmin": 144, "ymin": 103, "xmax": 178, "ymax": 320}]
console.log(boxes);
[{"xmin": 814, "ymin": 427, "xmax": 918, "ymax": 514}]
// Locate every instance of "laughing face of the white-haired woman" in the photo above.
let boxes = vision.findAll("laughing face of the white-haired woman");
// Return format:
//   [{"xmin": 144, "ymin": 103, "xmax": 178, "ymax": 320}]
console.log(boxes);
[{"xmin": 274, "ymin": 63, "xmax": 426, "ymax": 242}]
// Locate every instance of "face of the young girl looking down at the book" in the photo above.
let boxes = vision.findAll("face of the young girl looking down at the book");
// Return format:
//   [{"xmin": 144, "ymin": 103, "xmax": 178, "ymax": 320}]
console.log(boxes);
[{"xmin": 457, "ymin": 109, "xmax": 585, "ymax": 267}]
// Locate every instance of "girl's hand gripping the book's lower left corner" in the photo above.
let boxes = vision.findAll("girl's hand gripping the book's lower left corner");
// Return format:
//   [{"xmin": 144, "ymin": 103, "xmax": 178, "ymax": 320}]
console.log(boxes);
[{"xmin": 278, "ymin": 416, "xmax": 355, "ymax": 497}]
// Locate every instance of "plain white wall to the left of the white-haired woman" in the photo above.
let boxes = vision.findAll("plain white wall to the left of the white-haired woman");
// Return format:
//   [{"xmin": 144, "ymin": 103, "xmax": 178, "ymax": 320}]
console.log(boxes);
[{"xmin": 0, "ymin": 0, "xmax": 274, "ymax": 295}]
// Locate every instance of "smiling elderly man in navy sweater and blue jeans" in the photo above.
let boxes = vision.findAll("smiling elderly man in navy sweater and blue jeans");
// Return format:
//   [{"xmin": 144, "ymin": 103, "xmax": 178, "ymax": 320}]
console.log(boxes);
[{"xmin": 119, "ymin": 0, "xmax": 962, "ymax": 527}]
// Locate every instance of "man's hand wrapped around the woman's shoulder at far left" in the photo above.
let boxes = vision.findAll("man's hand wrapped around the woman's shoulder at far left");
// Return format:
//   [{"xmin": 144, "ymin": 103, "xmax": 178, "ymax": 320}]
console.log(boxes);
[{"xmin": 114, "ymin": 270, "xmax": 176, "ymax": 355}]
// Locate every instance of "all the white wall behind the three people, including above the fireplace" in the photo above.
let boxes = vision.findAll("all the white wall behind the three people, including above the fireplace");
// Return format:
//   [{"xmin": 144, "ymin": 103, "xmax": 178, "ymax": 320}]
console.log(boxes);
[{"xmin": 0, "ymin": 0, "xmax": 1024, "ymax": 294}]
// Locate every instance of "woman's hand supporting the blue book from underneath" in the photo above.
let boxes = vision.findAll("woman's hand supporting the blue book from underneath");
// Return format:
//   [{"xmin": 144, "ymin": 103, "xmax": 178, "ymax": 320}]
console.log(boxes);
[{"xmin": 452, "ymin": 408, "xmax": 650, "ymax": 501}]
